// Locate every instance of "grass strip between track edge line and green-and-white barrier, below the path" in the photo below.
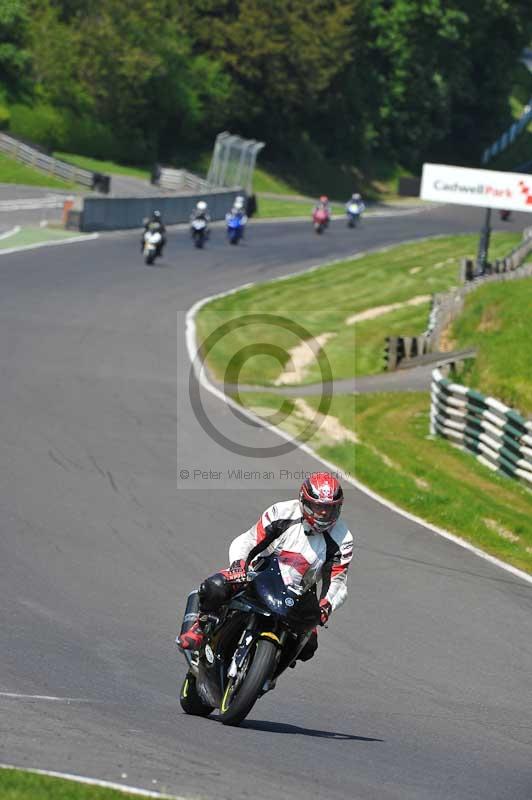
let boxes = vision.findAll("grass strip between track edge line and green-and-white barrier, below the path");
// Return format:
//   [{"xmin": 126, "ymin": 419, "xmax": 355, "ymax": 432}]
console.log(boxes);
[{"xmin": 241, "ymin": 392, "xmax": 532, "ymax": 572}]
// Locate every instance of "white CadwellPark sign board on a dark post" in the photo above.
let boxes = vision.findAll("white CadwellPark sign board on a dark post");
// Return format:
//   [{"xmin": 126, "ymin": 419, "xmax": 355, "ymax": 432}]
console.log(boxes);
[{"xmin": 420, "ymin": 164, "xmax": 532, "ymax": 211}]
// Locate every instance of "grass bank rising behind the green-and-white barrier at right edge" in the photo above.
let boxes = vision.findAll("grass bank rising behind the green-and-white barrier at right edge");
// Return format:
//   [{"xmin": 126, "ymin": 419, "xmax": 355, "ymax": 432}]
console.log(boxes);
[{"xmin": 450, "ymin": 278, "xmax": 532, "ymax": 414}]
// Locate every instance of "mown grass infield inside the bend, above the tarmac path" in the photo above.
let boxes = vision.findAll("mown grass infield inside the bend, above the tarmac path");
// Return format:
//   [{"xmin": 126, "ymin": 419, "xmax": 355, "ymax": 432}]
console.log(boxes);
[{"xmin": 197, "ymin": 227, "xmax": 520, "ymax": 386}]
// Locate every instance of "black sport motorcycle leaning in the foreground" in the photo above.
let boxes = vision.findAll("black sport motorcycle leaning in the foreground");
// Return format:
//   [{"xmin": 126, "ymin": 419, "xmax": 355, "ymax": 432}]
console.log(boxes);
[{"xmin": 180, "ymin": 556, "xmax": 320, "ymax": 725}]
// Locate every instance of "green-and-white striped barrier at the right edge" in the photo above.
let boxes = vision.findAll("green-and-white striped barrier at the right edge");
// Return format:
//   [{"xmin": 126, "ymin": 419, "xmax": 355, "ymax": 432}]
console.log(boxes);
[{"xmin": 430, "ymin": 369, "xmax": 532, "ymax": 485}]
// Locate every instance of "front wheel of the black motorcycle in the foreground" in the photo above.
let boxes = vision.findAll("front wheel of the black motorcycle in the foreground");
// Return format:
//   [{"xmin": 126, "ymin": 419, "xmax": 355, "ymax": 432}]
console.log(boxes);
[{"xmin": 220, "ymin": 639, "xmax": 277, "ymax": 725}]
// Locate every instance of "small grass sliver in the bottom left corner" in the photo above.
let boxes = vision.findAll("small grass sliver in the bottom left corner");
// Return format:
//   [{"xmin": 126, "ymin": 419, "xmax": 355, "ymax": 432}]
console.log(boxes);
[{"xmin": 0, "ymin": 769, "xmax": 172, "ymax": 800}]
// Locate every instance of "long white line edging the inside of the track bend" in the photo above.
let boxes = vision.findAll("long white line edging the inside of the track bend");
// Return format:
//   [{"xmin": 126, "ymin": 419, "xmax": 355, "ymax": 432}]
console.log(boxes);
[{"xmin": 185, "ymin": 244, "xmax": 532, "ymax": 585}]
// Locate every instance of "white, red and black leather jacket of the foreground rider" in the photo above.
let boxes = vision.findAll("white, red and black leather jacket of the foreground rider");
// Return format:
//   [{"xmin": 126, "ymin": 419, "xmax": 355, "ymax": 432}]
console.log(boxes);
[{"xmin": 229, "ymin": 500, "xmax": 353, "ymax": 611}]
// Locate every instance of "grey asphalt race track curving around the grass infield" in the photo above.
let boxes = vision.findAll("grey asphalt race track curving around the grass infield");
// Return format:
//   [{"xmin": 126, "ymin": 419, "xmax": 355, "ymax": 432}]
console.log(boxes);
[{"xmin": 0, "ymin": 208, "xmax": 532, "ymax": 800}]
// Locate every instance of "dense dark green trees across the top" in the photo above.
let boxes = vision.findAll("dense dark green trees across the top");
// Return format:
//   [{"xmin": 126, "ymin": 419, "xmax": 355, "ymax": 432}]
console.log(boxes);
[{"xmin": 0, "ymin": 0, "xmax": 532, "ymax": 169}]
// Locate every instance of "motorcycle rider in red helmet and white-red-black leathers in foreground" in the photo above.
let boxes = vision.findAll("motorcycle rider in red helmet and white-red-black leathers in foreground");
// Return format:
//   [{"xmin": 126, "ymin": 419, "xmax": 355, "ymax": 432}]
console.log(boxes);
[{"xmin": 176, "ymin": 472, "xmax": 353, "ymax": 661}]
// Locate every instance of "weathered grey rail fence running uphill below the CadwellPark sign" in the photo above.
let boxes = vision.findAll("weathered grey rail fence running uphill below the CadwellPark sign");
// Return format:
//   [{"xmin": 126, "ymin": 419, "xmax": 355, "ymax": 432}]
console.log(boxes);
[{"xmin": 384, "ymin": 228, "xmax": 532, "ymax": 370}]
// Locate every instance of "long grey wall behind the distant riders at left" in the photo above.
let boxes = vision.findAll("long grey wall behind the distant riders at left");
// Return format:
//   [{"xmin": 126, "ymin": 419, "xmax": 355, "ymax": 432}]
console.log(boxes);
[{"xmin": 79, "ymin": 189, "xmax": 239, "ymax": 232}]
